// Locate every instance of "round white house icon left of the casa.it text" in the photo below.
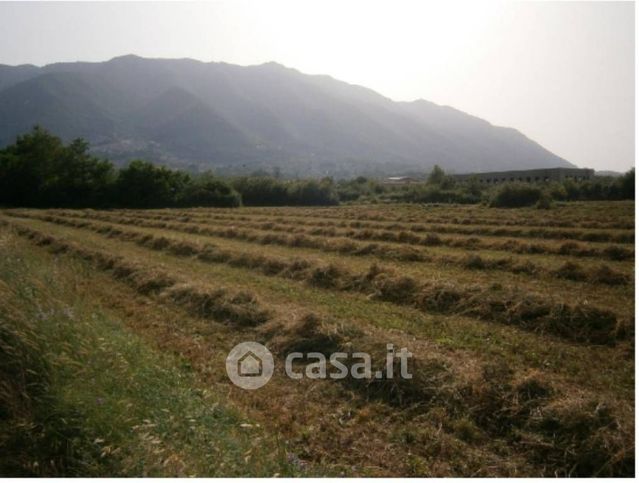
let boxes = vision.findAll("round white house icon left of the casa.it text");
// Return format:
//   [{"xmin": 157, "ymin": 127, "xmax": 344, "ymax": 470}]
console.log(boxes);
[{"xmin": 226, "ymin": 342, "xmax": 274, "ymax": 389}]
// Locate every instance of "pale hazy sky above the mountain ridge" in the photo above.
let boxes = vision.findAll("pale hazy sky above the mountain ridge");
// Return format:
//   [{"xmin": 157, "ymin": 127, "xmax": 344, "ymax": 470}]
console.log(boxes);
[{"xmin": 0, "ymin": 0, "xmax": 635, "ymax": 170}]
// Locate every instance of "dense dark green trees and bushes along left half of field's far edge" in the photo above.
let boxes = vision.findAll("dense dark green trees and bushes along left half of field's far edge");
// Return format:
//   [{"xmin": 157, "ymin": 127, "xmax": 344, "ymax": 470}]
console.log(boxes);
[{"xmin": 0, "ymin": 127, "xmax": 339, "ymax": 208}]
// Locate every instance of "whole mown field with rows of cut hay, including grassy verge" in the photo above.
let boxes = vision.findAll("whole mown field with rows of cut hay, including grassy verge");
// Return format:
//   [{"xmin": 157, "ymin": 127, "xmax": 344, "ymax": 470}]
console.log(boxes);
[{"xmin": 0, "ymin": 202, "xmax": 635, "ymax": 476}]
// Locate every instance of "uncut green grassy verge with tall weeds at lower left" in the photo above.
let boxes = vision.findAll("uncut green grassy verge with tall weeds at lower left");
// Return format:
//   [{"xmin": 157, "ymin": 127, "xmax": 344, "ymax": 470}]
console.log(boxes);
[{"xmin": 0, "ymin": 234, "xmax": 301, "ymax": 476}]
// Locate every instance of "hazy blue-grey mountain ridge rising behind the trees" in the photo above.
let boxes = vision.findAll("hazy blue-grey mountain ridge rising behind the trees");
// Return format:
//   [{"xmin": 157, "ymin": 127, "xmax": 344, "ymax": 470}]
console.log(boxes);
[{"xmin": 0, "ymin": 55, "xmax": 572, "ymax": 176}]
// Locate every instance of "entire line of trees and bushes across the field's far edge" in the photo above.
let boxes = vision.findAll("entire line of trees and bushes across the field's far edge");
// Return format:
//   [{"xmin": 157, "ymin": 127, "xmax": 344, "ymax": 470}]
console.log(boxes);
[{"xmin": 0, "ymin": 127, "xmax": 635, "ymax": 208}]
